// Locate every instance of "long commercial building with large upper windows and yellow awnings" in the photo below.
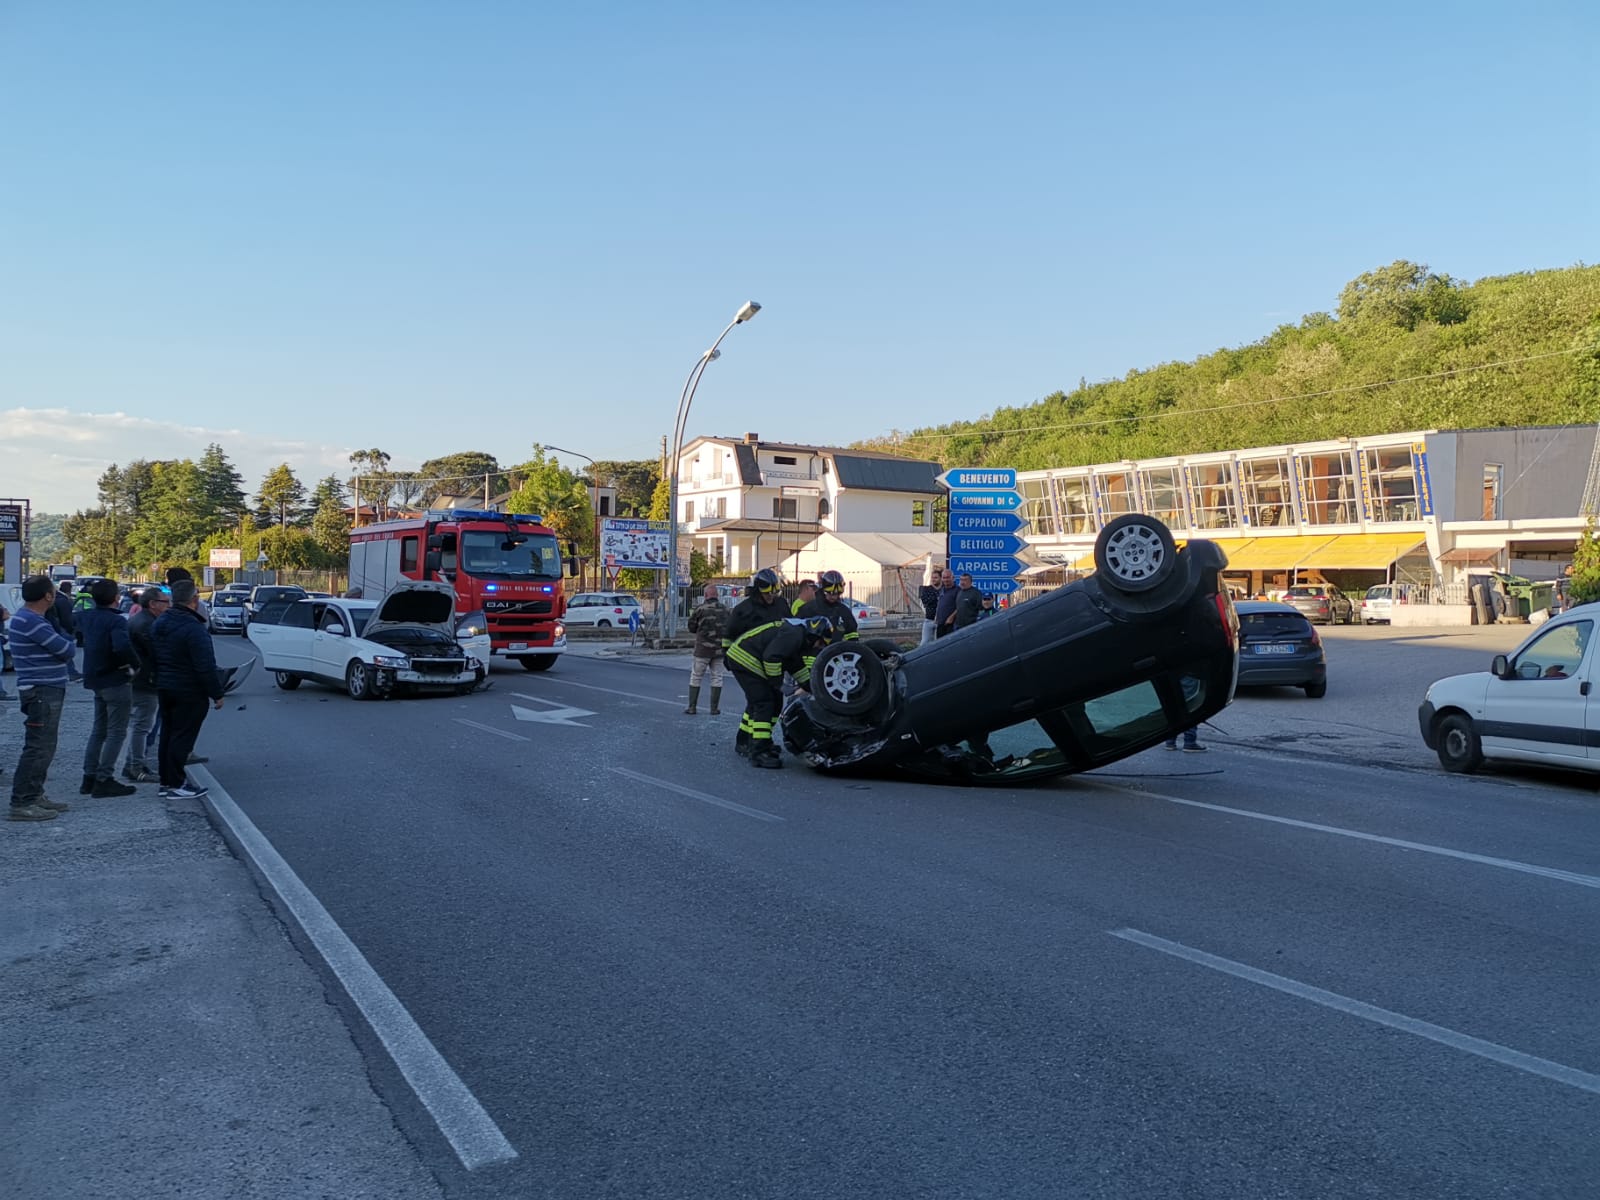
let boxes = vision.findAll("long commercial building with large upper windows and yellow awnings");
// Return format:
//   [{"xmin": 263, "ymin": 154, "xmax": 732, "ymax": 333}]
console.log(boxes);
[{"xmin": 1018, "ymin": 426, "xmax": 1595, "ymax": 595}]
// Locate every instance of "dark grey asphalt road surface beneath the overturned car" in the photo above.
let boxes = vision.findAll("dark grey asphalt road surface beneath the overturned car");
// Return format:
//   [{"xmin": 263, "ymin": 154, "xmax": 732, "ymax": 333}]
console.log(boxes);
[{"xmin": 203, "ymin": 629, "xmax": 1600, "ymax": 1198}]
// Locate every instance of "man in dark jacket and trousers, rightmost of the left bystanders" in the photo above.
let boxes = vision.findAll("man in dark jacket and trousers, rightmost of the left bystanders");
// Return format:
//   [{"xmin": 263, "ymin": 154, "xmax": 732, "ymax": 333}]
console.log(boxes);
[{"xmin": 150, "ymin": 579, "xmax": 222, "ymax": 800}]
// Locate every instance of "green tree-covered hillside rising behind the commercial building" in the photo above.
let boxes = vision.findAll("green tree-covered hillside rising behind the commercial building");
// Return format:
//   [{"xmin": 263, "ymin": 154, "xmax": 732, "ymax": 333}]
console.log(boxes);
[{"xmin": 862, "ymin": 262, "xmax": 1600, "ymax": 470}]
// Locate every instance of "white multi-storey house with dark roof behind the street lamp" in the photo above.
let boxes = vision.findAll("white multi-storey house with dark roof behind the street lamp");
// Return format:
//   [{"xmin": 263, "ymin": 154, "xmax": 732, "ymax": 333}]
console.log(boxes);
[{"xmin": 678, "ymin": 434, "xmax": 944, "ymax": 574}]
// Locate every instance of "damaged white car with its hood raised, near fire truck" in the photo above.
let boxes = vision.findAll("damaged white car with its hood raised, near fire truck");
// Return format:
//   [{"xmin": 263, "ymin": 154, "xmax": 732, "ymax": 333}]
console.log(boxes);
[{"xmin": 250, "ymin": 581, "xmax": 488, "ymax": 699}]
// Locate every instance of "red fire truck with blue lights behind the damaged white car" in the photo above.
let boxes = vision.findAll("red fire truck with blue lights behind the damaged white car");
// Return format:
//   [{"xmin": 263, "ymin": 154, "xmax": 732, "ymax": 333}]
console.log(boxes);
[{"xmin": 350, "ymin": 509, "xmax": 578, "ymax": 670}]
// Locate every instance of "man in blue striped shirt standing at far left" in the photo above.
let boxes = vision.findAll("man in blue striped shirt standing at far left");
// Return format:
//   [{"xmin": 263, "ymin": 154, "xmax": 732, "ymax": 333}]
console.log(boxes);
[{"xmin": 6, "ymin": 574, "xmax": 77, "ymax": 821}]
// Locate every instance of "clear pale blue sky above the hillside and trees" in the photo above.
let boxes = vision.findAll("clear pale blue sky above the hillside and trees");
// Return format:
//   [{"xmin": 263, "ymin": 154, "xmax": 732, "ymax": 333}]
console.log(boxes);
[{"xmin": 0, "ymin": 0, "xmax": 1600, "ymax": 510}]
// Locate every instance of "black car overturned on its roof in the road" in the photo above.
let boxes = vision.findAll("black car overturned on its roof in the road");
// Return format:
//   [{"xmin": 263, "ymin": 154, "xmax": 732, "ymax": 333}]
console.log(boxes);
[{"xmin": 782, "ymin": 514, "xmax": 1238, "ymax": 786}]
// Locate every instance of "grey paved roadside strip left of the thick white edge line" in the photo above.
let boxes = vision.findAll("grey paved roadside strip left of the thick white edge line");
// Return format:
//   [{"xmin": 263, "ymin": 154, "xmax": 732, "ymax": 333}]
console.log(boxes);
[{"xmin": 0, "ymin": 675, "xmax": 440, "ymax": 1200}]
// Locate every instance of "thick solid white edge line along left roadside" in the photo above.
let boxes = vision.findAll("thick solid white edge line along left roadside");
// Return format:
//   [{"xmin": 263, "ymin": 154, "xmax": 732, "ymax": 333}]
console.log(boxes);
[{"xmin": 190, "ymin": 766, "xmax": 517, "ymax": 1171}]
